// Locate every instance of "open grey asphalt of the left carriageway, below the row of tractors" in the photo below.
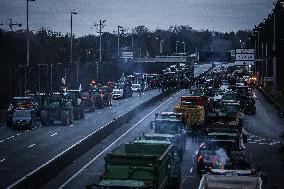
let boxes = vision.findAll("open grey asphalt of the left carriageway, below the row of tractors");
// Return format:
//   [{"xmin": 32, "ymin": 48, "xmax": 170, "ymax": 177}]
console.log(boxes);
[{"xmin": 0, "ymin": 90, "xmax": 160, "ymax": 188}]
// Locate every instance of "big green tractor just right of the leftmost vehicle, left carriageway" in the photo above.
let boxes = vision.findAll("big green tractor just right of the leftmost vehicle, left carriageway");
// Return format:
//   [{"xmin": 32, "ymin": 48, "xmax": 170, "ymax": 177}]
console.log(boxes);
[{"xmin": 40, "ymin": 93, "xmax": 74, "ymax": 126}]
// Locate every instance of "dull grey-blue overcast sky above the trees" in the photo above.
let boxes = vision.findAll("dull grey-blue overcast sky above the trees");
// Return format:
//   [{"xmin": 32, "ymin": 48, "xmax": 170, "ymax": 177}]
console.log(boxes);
[{"xmin": 0, "ymin": 0, "xmax": 274, "ymax": 37}]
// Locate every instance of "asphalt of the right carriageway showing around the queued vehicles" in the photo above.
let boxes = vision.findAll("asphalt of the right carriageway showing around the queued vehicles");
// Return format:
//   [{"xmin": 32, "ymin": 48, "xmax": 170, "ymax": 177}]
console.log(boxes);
[{"xmin": 43, "ymin": 85, "xmax": 284, "ymax": 189}]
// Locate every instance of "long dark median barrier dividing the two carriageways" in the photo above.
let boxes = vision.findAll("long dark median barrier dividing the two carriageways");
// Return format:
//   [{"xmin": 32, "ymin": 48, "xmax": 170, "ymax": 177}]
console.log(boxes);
[{"xmin": 8, "ymin": 92, "xmax": 171, "ymax": 189}]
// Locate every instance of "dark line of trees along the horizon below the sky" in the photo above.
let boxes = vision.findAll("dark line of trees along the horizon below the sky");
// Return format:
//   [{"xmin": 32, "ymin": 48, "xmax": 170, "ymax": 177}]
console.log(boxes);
[{"xmin": 0, "ymin": 25, "xmax": 249, "ymax": 107}]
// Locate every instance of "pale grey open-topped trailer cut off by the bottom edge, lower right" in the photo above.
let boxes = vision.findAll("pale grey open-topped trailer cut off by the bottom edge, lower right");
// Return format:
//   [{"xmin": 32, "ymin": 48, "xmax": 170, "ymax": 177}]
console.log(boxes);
[{"xmin": 198, "ymin": 170, "xmax": 262, "ymax": 189}]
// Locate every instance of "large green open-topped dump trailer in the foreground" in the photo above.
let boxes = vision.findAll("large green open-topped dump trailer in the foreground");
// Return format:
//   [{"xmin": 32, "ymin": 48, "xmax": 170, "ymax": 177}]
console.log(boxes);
[{"xmin": 91, "ymin": 141, "xmax": 179, "ymax": 189}]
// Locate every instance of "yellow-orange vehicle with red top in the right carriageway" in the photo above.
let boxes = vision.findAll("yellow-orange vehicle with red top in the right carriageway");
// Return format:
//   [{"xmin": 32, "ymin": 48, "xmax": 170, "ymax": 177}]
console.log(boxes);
[{"xmin": 174, "ymin": 96, "xmax": 205, "ymax": 128}]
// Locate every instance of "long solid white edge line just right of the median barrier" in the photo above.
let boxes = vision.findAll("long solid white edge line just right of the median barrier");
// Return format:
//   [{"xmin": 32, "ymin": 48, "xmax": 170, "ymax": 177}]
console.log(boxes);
[{"xmin": 58, "ymin": 92, "xmax": 173, "ymax": 189}]
